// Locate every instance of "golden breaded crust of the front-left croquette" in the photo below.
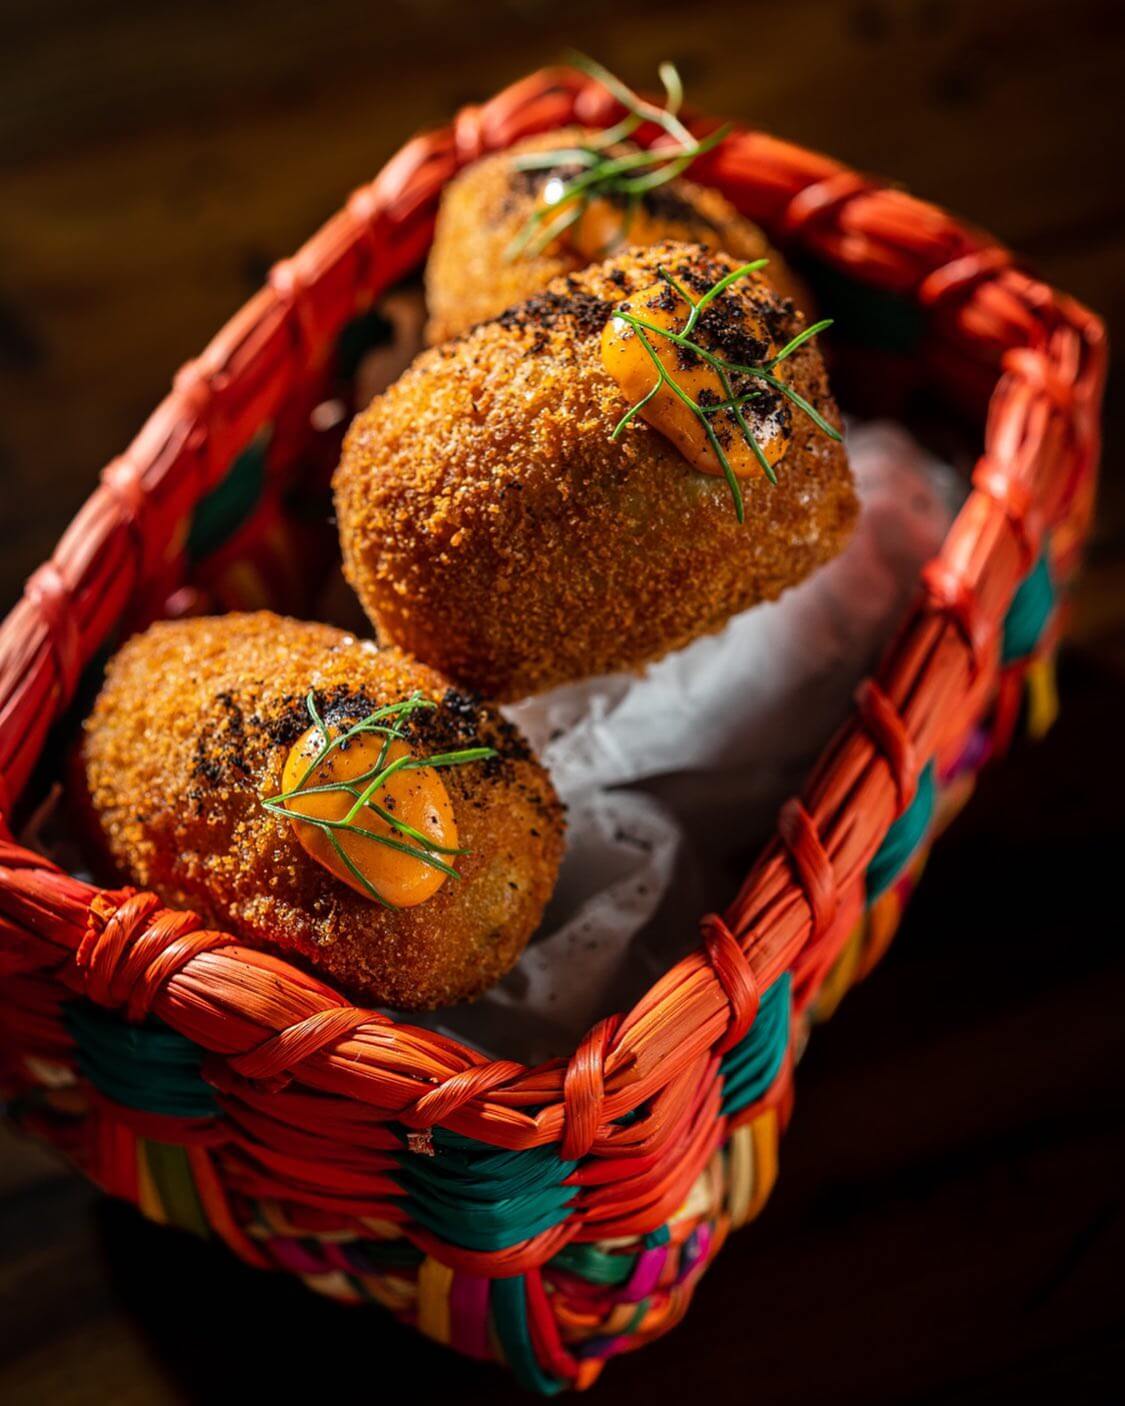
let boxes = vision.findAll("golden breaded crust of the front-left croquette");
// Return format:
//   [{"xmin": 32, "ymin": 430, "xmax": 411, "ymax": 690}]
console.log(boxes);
[{"xmin": 84, "ymin": 613, "xmax": 564, "ymax": 1010}]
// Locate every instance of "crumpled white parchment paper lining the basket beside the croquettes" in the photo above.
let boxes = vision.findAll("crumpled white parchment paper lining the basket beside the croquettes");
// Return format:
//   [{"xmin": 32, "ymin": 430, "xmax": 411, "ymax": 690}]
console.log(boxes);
[{"xmin": 425, "ymin": 423, "xmax": 963, "ymax": 1062}]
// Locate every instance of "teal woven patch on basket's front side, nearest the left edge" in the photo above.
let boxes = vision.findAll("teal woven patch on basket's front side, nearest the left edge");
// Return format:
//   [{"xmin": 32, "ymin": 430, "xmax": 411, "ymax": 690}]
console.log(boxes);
[{"xmin": 63, "ymin": 1001, "xmax": 218, "ymax": 1118}]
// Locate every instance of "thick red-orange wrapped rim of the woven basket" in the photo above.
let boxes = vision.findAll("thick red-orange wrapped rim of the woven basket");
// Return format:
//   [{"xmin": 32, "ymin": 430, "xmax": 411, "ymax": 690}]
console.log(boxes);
[{"xmin": 0, "ymin": 67, "xmax": 1105, "ymax": 1156}]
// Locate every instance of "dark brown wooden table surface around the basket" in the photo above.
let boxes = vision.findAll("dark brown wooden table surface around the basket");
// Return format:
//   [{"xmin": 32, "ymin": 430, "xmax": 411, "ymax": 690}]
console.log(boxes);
[{"xmin": 0, "ymin": 0, "xmax": 1125, "ymax": 1406}]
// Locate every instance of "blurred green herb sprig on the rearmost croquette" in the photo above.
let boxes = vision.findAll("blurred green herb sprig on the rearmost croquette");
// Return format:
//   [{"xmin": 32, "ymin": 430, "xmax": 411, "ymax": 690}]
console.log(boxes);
[{"xmin": 505, "ymin": 53, "xmax": 731, "ymax": 260}]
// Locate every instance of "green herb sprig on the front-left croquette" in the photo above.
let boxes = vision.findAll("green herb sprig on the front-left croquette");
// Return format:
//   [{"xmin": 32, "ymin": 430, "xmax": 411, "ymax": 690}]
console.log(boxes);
[{"xmin": 262, "ymin": 690, "xmax": 496, "ymax": 908}]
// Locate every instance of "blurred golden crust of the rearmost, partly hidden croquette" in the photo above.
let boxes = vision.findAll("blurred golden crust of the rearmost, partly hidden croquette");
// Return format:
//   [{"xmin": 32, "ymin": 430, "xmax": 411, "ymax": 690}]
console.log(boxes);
[{"xmin": 426, "ymin": 127, "xmax": 806, "ymax": 346}]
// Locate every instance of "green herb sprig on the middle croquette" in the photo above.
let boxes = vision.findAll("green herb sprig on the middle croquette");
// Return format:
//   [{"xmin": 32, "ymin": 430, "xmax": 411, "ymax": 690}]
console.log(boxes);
[{"xmin": 610, "ymin": 259, "xmax": 842, "ymax": 523}]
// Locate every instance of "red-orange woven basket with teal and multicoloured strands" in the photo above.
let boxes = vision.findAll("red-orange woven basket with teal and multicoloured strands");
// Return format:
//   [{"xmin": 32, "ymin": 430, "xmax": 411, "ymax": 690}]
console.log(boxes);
[{"xmin": 0, "ymin": 70, "xmax": 1105, "ymax": 1392}]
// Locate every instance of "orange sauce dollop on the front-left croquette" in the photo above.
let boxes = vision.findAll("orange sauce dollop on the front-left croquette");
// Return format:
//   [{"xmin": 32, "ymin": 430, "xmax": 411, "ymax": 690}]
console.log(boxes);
[{"xmin": 283, "ymin": 725, "xmax": 457, "ymax": 908}]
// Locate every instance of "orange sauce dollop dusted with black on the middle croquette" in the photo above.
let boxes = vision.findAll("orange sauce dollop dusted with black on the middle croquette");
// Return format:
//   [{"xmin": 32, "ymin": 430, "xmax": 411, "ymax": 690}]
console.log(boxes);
[{"xmin": 602, "ymin": 281, "xmax": 789, "ymax": 478}]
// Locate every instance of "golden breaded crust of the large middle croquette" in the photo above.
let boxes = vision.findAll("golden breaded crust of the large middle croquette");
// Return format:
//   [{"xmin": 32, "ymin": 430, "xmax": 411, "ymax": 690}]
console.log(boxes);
[{"xmin": 335, "ymin": 245, "xmax": 856, "ymax": 699}]
